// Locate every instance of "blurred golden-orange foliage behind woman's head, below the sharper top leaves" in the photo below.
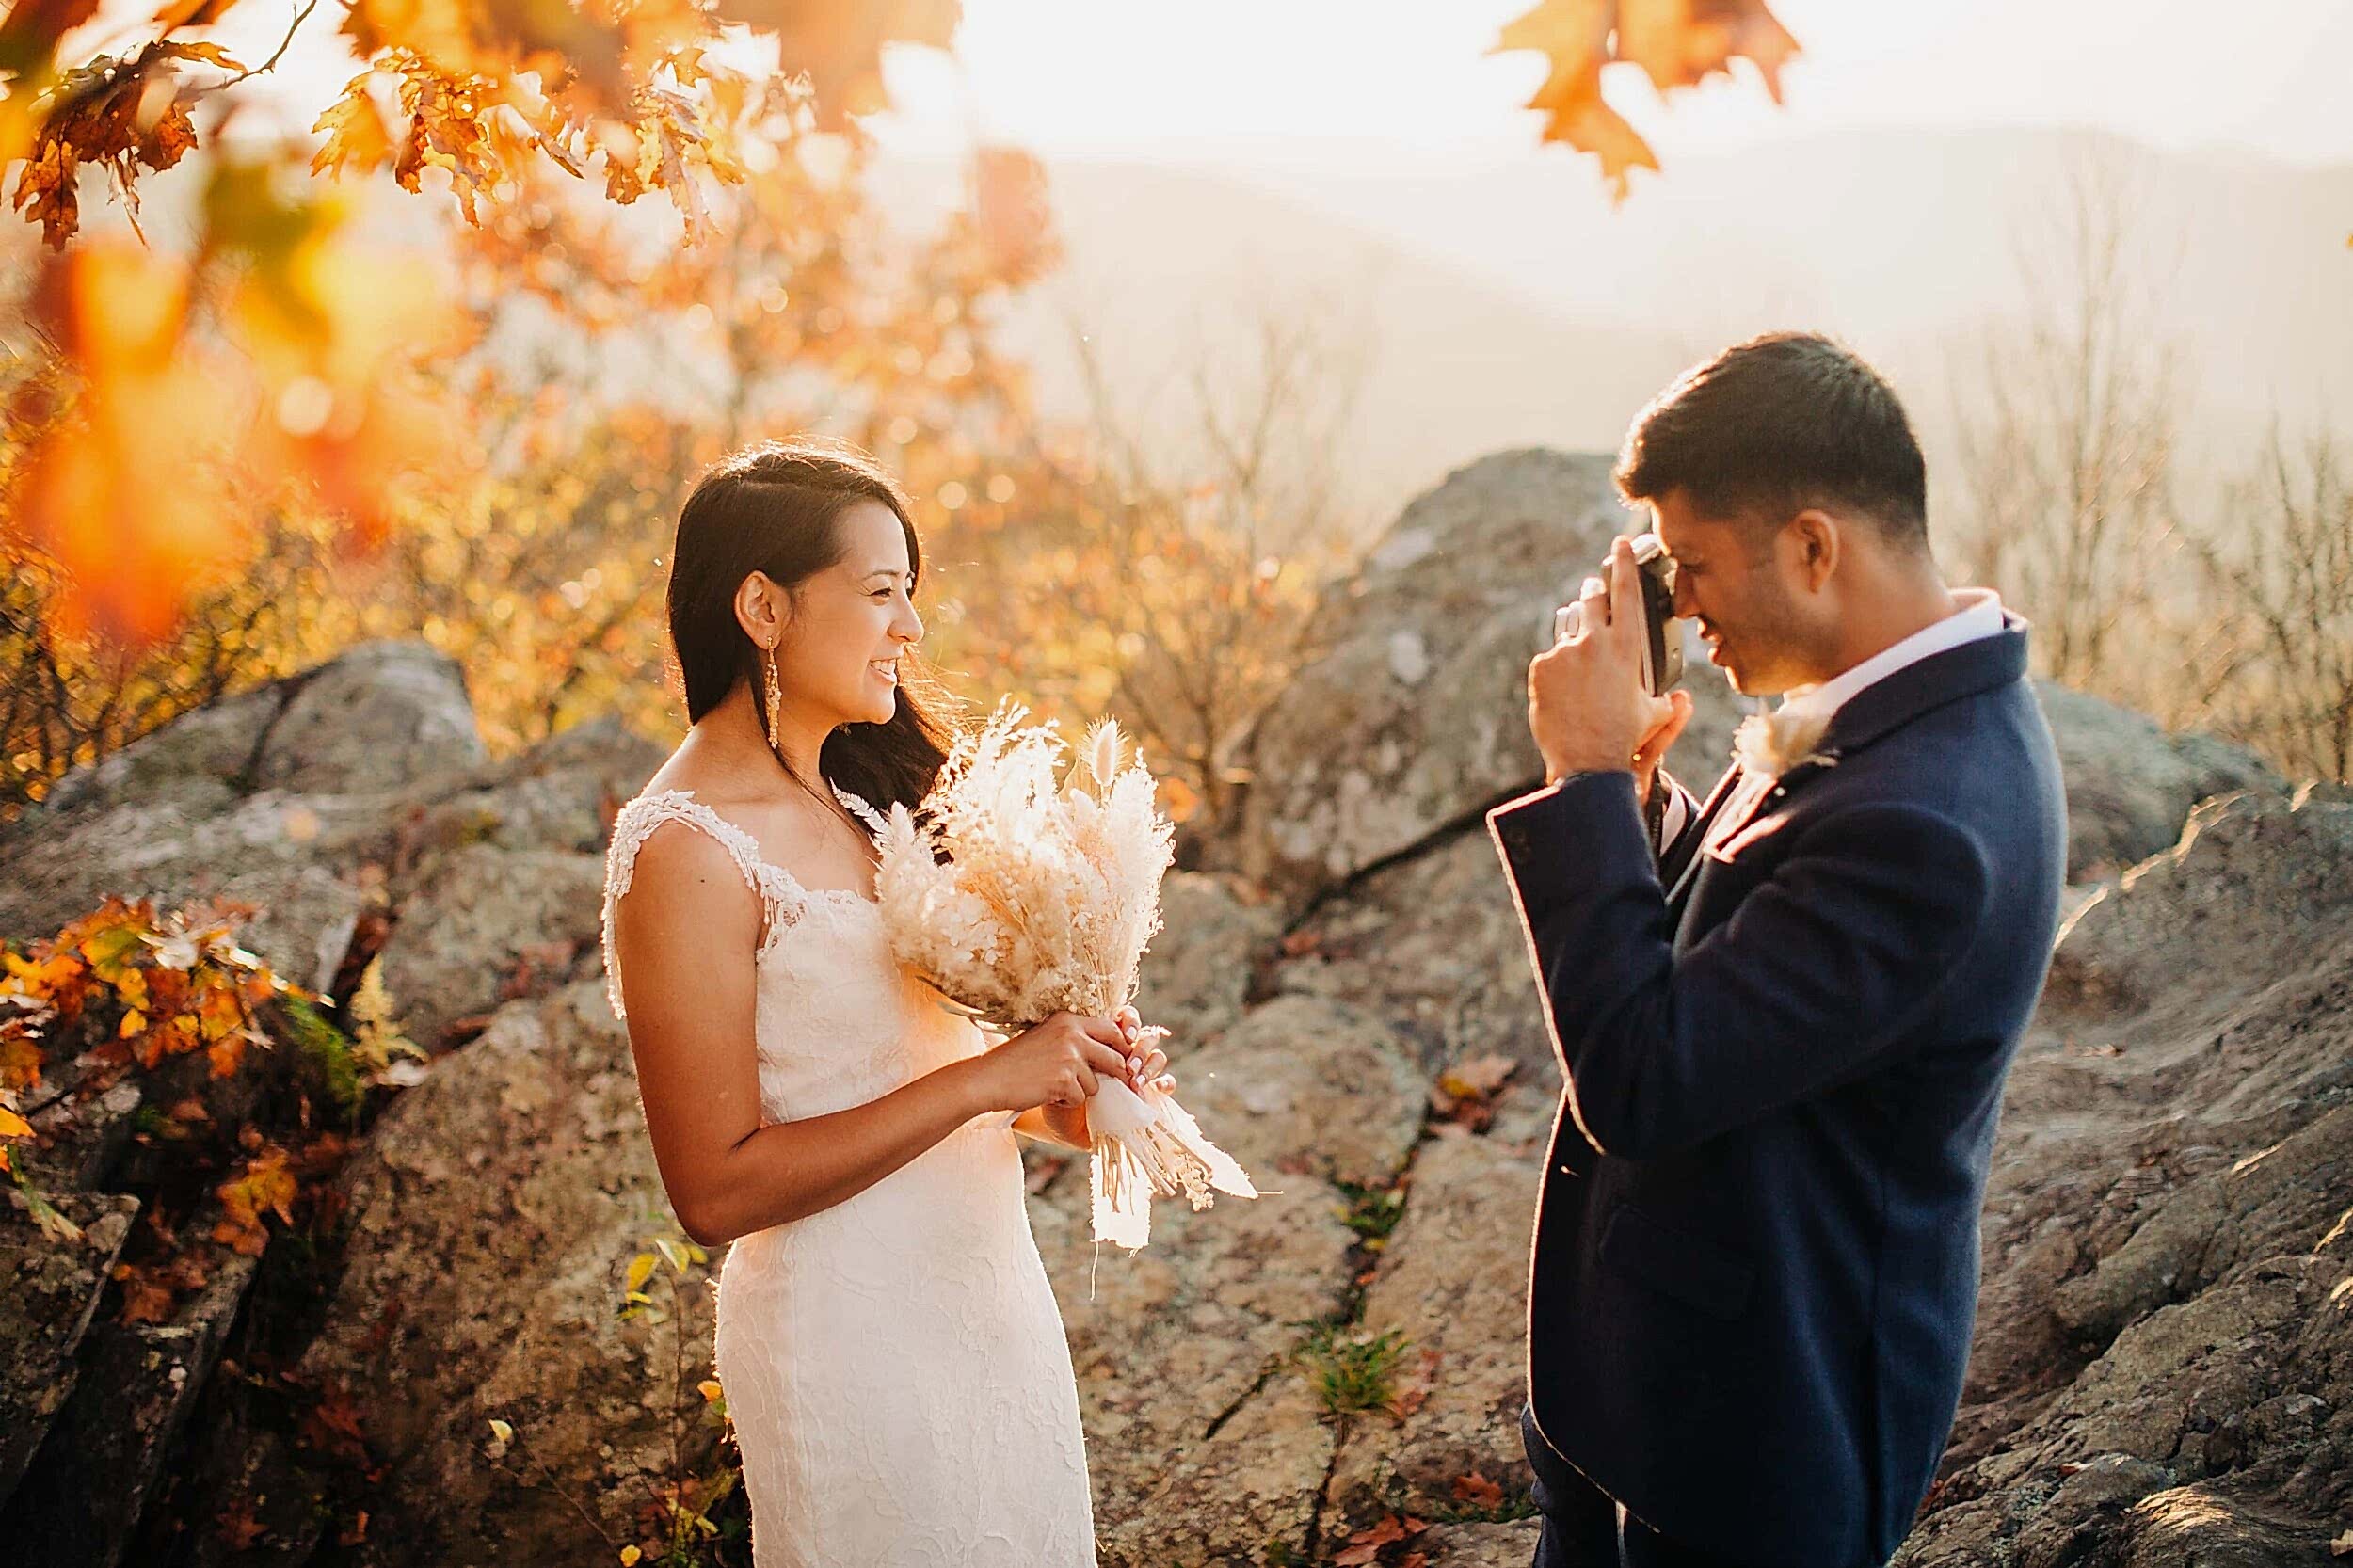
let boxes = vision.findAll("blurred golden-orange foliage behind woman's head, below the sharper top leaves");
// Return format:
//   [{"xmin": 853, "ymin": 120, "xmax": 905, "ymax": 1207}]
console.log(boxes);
[{"xmin": 0, "ymin": 102, "xmax": 1332, "ymax": 838}]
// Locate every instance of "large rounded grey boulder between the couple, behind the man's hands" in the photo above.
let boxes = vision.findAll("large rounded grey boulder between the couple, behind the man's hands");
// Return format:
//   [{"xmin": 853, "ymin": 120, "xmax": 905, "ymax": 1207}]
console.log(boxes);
[{"xmin": 1242, "ymin": 450, "xmax": 1735, "ymax": 902}]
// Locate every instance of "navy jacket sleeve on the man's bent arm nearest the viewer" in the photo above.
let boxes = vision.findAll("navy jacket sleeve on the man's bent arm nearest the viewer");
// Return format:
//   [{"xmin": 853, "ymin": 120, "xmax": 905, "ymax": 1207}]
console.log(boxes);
[{"xmin": 1487, "ymin": 772, "xmax": 1989, "ymax": 1159}]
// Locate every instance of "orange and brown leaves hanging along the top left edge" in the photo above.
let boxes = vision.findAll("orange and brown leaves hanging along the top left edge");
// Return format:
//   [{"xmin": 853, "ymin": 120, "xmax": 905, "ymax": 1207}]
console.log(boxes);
[{"xmin": 0, "ymin": 0, "xmax": 960, "ymax": 245}]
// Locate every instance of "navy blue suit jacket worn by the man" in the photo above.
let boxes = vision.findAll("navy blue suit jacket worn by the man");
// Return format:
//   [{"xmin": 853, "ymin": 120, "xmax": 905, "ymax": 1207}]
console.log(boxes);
[{"xmin": 1487, "ymin": 619, "xmax": 2066, "ymax": 1568}]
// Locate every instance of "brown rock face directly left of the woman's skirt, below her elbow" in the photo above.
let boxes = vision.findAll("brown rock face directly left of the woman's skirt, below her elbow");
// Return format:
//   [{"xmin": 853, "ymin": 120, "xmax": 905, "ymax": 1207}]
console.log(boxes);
[{"xmin": 282, "ymin": 980, "xmax": 718, "ymax": 1563}]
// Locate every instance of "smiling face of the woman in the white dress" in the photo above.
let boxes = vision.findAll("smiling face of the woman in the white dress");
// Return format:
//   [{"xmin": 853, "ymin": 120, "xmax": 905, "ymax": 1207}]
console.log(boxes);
[{"xmin": 776, "ymin": 502, "xmax": 922, "ymax": 728}]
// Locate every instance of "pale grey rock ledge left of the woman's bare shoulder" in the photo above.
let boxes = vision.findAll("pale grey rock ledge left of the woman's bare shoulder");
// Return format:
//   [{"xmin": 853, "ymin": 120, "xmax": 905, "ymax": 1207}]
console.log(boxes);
[{"xmin": 0, "ymin": 643, "xmax": 662, "ymax": 1002}]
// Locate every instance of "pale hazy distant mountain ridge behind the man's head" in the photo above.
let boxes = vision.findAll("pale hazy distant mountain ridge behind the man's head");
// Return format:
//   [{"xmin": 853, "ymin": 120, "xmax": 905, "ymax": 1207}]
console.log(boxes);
[{"xmin": 875, "ymin": 130, "xmax": 2353, "ymax": 513}]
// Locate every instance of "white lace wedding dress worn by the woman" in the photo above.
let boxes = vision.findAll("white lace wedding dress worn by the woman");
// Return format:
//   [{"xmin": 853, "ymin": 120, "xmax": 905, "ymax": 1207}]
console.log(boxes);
[{"xmin": 605, "ymin": 789, "xmax": 1095, "ymax": 1568}]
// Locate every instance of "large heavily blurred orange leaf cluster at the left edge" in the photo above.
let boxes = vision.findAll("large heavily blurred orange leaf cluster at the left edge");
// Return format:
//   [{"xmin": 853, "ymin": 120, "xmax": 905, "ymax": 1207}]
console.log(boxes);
[{"xmin": 5, "ymin": 163, "xmax": 461, "ymax": 648}]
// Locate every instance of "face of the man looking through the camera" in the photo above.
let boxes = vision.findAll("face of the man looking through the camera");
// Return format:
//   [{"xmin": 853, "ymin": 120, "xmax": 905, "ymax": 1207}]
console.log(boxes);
[{"xmin": 1650, "ymin": 489, "xmax": 1817, "ymax": 696}]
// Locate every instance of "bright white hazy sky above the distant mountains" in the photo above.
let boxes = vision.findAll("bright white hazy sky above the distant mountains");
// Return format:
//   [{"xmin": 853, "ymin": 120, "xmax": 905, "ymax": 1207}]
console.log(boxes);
[{"xmin": 101, "ymin": 0, "xmax": 2353, "ymax": 163}]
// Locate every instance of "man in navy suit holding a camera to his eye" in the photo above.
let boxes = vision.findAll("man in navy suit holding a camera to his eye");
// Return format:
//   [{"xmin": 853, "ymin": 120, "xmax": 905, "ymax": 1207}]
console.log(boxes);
[{"xmin": 1487, "ymin": 334, "xmax": 2066, "ymax": 1568}]
